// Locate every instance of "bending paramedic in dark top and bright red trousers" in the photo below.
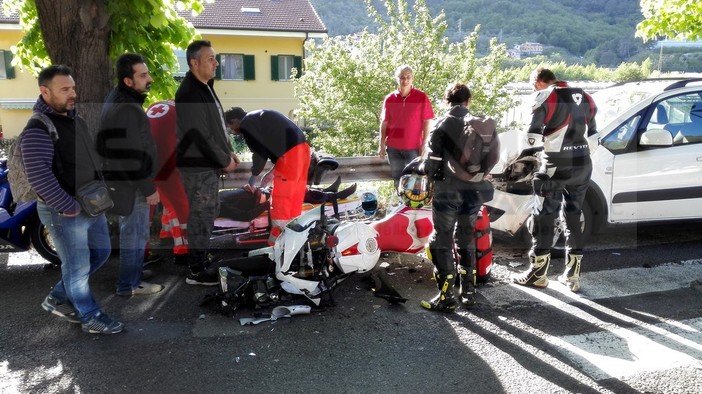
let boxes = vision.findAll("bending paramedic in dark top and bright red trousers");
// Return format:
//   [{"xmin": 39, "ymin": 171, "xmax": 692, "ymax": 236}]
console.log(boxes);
[{"xmin": 224, "ymin": 107, "xmax": 310, "ymax": 243}]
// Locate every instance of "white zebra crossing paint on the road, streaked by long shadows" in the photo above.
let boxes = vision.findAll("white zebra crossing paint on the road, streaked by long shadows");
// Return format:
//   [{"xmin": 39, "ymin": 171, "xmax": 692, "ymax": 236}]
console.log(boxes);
[{"xmin": 511, "ymin": 260, "xmax": 702, "ymax": 380}]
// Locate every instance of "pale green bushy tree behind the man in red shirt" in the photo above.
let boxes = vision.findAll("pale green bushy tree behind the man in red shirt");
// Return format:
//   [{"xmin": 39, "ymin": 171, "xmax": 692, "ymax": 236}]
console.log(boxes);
[{"xmin": 295, "ymin": 0, "xmax": 512, "ymax": 156}]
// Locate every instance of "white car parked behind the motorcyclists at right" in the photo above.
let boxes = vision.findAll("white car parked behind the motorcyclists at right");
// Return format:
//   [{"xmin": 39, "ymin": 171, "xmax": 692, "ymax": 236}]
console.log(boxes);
[{"xmin": 486, "ymin": 78, "xmax": 702, "ymax": 242}]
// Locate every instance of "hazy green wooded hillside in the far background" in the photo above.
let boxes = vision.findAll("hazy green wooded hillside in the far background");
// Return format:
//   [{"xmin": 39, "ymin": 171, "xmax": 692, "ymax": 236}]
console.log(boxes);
[{"xmin": 311, "ymin": 0, "xmax": 645, "ymax": 66}]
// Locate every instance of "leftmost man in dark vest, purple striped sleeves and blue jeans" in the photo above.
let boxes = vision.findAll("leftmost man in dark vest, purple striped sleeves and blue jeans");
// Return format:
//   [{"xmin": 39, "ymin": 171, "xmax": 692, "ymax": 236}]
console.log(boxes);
[{"xmin": 20, "ymin": 65, "xmax": 124, "ymax": 334}]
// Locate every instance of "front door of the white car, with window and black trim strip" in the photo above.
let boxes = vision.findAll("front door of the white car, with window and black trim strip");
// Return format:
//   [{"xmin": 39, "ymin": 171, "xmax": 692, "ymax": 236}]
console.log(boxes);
[{"xmin": 610, "ymin": 92, "xmax": 702, "ymax": 222}]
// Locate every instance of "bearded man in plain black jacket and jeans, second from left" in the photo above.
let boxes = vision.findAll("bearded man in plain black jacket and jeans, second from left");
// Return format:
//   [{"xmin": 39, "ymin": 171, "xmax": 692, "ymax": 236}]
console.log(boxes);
[{"xmin": 97, "ymin": 53, "xmax": 163, "ymax": 297}]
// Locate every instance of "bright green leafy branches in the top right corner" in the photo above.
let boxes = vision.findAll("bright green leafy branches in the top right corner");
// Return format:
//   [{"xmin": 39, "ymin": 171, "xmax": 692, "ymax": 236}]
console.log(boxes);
[{"xmin": 636, "ymin": 0, "xmax": 702, "ymax": 40}]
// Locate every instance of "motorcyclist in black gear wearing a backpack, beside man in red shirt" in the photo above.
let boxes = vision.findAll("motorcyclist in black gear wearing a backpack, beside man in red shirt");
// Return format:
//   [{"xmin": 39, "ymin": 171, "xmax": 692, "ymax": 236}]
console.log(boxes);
[{"xmin": 420, "ymin": 83, "xmax": 499, "ymax": 312}]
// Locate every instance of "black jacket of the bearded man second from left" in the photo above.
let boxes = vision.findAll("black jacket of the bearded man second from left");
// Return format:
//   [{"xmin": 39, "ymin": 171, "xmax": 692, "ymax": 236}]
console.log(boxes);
[{"xmin": 96, "ymin": 85, "xmax": 158, "ymax": 215}]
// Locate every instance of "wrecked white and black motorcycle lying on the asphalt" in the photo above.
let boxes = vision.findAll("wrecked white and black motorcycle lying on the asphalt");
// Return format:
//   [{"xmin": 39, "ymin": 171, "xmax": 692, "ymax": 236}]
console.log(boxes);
[{"xmin": 203, "ymin": 199, "xmax": 380, "ymax": 314}]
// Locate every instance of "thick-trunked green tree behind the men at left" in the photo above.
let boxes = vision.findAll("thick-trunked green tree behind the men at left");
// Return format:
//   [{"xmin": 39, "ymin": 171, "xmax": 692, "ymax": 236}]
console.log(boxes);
[{"xmin": 4, "ymin": 0, "xmax": 203, "ymax": 124}]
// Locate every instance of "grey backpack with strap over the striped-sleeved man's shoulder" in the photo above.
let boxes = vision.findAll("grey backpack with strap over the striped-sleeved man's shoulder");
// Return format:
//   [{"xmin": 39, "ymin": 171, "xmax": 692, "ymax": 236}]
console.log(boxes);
[{"xmin": 7, "ymin": 112, "xmax": 58, "ymax": 202}]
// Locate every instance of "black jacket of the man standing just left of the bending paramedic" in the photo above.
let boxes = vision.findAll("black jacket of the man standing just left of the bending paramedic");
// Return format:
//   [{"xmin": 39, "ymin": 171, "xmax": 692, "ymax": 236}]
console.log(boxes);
[{"xmin": 175, "ymin": 71, "xmax": 232, "ymax": 172}]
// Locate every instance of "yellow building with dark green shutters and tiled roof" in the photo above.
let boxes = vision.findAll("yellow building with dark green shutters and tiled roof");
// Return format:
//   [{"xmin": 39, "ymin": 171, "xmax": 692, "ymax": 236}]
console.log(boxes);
[{"xmin": 0, "ymin": 0, "xmax": 327, "ymax": 138}]
